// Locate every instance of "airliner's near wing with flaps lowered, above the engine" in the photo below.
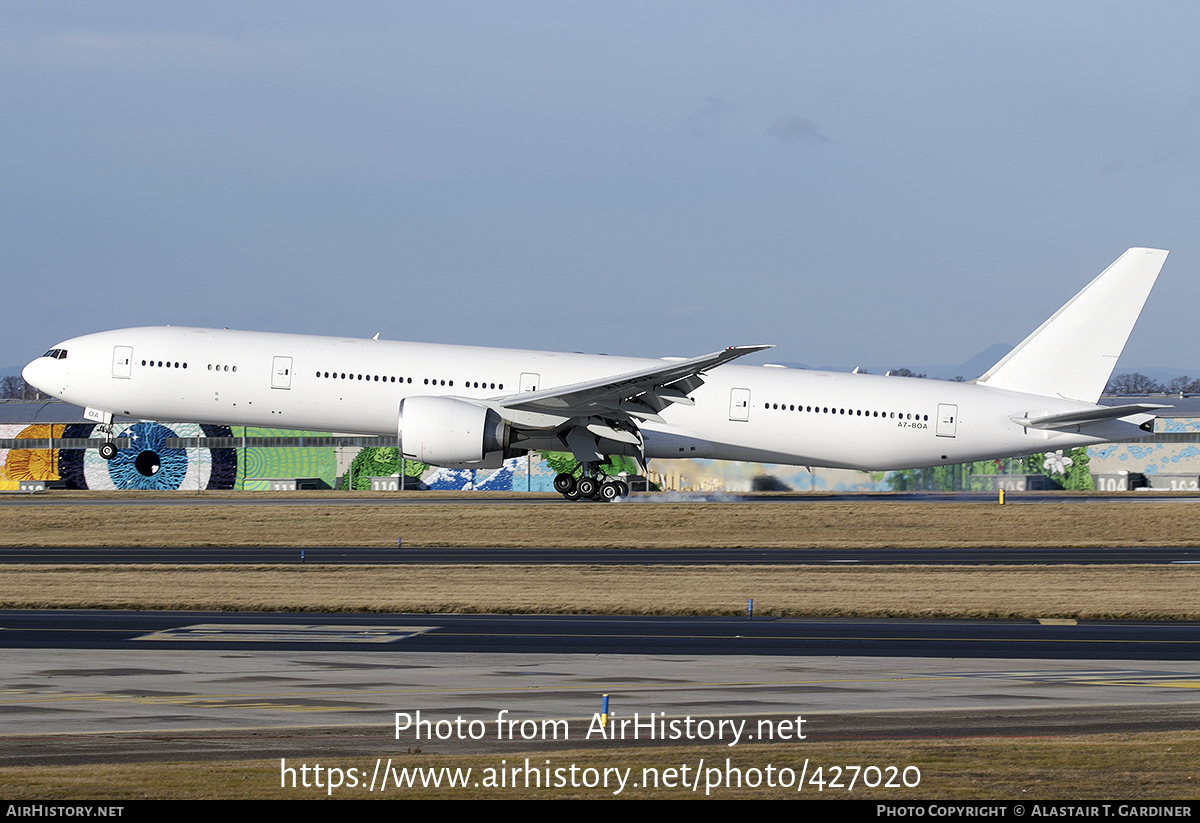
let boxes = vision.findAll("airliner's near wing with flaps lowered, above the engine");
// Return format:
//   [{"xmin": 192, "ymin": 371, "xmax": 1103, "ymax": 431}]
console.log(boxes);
[{"xmin": 488, "ymin": 346, "xmax": 773, "ymax": 420}]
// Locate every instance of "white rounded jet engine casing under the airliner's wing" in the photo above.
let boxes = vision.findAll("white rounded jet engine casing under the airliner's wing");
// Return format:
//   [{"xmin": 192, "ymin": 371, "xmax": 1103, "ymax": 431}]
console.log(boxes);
[{"xmin": 398, "ymin": 397, "xmax": 509, "ymax": 465}]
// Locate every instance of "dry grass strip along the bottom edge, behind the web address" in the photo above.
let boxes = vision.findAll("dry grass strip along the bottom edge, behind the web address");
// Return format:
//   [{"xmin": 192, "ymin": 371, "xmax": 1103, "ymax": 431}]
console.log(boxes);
[{"xmin": 0, "ymin": 732, "xmax": 1200, "ymax": 813}]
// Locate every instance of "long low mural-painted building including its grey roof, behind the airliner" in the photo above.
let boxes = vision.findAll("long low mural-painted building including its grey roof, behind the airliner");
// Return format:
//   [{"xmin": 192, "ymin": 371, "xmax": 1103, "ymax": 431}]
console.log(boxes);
[{"xmin": 0, "ymin": 397, "xmax": 1200, "ymax": 492}]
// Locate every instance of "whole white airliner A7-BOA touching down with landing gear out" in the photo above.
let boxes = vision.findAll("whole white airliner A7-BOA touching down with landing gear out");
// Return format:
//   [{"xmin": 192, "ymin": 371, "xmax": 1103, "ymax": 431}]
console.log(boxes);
[{"xmin": 23, "ymin": 248, "xmax": 1166, "ymax": 499}]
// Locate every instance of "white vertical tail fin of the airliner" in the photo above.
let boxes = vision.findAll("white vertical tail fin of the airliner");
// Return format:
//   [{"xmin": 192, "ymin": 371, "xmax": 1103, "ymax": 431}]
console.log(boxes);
[{"xmin": 977, "ymin": 248, "xmax": 1166, "ymax": 403}]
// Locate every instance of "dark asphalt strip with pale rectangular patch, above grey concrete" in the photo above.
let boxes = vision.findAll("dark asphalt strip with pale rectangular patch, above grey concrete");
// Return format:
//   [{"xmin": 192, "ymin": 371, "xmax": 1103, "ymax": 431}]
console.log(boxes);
[{"xmin": 7, "ymin": 609, "xmax": 1200, "ymax": 661}]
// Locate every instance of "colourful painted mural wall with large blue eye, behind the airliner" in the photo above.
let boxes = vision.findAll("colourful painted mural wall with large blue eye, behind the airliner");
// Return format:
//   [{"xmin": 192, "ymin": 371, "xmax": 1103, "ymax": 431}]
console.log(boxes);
[{"xmin": 0, "ymin": 419, "xmax": 1200, "ymax": 492}]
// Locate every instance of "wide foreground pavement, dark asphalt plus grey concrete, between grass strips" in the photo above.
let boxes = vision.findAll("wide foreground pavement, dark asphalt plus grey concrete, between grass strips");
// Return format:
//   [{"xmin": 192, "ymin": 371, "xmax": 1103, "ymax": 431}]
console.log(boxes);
[{"xmin": 0, "ymin": 612, "xmax": 1200, "ymax": 765}]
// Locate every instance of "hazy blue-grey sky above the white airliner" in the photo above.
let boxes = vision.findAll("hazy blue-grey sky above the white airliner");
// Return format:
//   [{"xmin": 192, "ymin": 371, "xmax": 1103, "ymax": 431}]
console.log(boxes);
[{"xmin": 0, "ymin": 0, "xmax": 1200, "ymax": 377}]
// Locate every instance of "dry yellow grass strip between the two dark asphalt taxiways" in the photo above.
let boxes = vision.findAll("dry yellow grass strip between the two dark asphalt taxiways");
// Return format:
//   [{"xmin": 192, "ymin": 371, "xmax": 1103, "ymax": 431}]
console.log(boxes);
[{"xmin": 0, "ymin": 565, "xmax": 1200, "ymax": 619}]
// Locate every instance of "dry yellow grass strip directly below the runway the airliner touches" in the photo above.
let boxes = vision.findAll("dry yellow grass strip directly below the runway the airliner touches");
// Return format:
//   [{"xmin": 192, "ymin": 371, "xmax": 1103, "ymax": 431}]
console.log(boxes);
[{"xmin": 7, "ymin": 498, "xmax": 1200, "ymax": 548}]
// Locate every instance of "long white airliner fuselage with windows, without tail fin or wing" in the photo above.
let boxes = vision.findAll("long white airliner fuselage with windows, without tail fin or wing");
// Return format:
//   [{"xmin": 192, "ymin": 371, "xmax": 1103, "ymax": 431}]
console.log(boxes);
[{"xmin": 24, "ymin": 326, "xmax": 1148, "ymax": 470}]
